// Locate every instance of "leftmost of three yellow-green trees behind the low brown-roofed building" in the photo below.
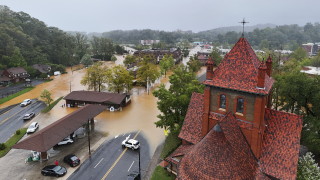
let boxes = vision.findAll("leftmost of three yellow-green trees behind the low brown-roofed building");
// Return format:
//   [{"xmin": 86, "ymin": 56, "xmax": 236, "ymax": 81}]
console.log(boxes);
[{"xmin": 80, "ymin": 62, "xmax": 108, "ymax": 92}]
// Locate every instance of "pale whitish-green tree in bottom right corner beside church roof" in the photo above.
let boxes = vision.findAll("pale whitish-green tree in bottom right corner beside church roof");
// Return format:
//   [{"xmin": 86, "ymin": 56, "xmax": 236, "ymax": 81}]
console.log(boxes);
[{"xmin": 297, "ymin": 152, "xmax": 320, "ymax": 180}]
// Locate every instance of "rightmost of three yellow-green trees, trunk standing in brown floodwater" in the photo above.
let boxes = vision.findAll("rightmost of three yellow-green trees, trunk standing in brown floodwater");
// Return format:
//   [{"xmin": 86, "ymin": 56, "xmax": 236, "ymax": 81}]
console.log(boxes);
[{"xmin": 137, "ymin": 62, "xmax": 160, "ymax": 94}]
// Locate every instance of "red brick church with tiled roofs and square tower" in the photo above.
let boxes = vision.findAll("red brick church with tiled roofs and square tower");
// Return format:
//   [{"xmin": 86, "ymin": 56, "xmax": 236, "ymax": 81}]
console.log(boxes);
[{"xmin": 165, "ymin": 37, "xmax": 302, "ymax": 180}]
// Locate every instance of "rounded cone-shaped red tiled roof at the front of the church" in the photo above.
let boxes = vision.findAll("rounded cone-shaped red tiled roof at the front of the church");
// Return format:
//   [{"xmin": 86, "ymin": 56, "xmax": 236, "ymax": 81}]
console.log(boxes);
[{"xmin": 178, "ymin": 114, "xmax": 258, "ymax": 180}]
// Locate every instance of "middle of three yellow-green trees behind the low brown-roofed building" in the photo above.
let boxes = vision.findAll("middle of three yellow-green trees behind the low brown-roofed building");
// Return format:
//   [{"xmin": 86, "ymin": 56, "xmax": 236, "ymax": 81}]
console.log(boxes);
[{"xmin": 106, "ymin": 65, "xmax": 133, "ymax": 93}]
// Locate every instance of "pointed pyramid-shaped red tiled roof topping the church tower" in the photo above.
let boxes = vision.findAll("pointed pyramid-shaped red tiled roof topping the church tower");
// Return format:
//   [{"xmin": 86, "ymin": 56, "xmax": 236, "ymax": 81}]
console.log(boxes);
[{"xmin": 204, "ymin": 38, "xmax": 274, "ymax": 94}]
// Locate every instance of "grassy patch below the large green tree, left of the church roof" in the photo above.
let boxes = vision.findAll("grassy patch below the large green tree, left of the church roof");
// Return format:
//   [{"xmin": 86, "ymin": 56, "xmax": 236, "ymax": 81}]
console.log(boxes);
[{"xmin": 160, "ymin": 133, "xmax": 181, "ymax": 159}]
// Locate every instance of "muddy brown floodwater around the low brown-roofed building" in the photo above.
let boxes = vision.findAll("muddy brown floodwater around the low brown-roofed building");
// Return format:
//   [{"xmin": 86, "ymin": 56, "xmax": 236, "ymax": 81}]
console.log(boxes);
[{"xmin": 0, "ymin": 63, "xmax": 168, "ymax": 153}]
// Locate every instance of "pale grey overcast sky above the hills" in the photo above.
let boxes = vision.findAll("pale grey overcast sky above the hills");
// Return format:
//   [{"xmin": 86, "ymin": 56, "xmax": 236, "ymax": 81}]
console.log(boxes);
[{"xmin": 0, "ymin": 0, "xmax": 320, "ymax": 32}]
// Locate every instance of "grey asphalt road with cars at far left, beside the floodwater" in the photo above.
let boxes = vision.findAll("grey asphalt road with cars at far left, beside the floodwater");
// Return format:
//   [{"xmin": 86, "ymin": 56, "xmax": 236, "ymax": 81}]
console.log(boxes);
[{"xmin": 0, "ymin": 99, "xmax": 46, "ymax": 143}]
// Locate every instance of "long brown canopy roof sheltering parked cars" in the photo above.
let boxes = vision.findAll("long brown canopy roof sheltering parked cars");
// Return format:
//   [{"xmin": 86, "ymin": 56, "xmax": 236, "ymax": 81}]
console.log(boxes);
[{"xmin": 13, "ymin": 104, "xmax": 105, "ymax": 152}]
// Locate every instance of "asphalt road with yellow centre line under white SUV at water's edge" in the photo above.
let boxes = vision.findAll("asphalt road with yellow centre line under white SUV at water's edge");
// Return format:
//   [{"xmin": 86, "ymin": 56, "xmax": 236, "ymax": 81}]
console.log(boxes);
[{"xmin": 68, "ymin": 132, "xmax": 151, "ymax": 180}]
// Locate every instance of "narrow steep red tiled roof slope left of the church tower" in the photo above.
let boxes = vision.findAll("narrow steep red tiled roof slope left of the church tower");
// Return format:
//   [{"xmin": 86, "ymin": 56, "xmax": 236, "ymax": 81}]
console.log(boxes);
[{"xmin": 179, "ymin": 93, "xmax": 203, "ymax": 144}]
